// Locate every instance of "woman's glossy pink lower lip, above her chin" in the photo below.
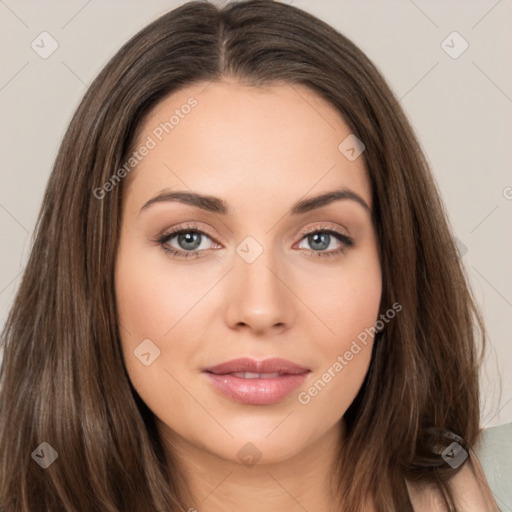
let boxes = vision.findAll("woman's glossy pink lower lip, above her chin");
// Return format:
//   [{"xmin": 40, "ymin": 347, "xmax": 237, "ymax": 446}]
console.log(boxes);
[{"xmin": 205, "ymin": 372, "xmax": 309, "ymax": 405}]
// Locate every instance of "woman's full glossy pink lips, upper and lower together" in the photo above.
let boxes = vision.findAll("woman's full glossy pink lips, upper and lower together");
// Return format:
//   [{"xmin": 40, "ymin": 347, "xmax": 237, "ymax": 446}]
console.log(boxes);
[{"xmin": 204, "ymin": 358, "xmax": 311, "ymax": 405}]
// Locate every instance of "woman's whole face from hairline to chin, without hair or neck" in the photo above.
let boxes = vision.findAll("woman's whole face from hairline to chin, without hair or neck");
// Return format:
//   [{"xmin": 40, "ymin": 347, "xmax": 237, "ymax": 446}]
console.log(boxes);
[{"xmin": 114, "ymin": 81, "xmax": 381, "ymax": 463}]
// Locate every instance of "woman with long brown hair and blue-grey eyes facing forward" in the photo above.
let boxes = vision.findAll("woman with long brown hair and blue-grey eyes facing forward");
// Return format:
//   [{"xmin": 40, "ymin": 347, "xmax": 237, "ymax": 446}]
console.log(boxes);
[{"xmin": 0, "ymin": 0, "xmax": 504, "ymax": 512}]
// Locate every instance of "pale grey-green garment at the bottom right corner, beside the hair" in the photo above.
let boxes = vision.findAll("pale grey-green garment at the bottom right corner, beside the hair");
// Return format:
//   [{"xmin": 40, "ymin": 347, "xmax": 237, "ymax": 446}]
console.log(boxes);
[{"xmin": 473, "ymin": 423, "xmax": 512, "ymax": 512}]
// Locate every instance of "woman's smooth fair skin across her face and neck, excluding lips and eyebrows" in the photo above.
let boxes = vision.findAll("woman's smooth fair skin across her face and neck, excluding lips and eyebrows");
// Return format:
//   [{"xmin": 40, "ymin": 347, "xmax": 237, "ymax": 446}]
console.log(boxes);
[{"xmin": 115, "ymin": 79, "xmax": 382, "ymax": 512}]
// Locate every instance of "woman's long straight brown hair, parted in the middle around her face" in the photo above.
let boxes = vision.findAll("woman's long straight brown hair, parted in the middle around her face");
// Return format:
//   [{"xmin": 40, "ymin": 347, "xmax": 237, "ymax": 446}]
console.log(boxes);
[{"xmin": 0, "ymin": 0, "xmax": 485, "ymax": 512}]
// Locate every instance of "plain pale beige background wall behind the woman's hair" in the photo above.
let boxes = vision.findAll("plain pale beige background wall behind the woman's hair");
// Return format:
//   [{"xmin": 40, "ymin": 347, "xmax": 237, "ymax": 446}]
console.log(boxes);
[{"xmin": 0, "ymin": 0, "xmax": 512, "ymax": 426}]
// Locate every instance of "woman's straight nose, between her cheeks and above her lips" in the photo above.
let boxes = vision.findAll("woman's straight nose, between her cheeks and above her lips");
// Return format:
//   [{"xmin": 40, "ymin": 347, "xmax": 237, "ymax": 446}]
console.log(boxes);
[{"xmin": 225, "ymin": 244, "xmax": 297, "ymax": 335}]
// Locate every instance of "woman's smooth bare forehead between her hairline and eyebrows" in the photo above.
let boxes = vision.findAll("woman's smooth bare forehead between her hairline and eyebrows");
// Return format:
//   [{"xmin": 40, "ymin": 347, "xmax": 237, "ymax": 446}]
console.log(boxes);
[{"xmin": 126, "ymin": 80, "xmax": 371, "ymax": 214}]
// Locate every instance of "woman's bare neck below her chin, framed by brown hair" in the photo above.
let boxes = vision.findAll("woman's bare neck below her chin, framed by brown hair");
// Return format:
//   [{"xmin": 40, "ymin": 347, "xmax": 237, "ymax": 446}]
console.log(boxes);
[{"xmin": 159, "ymin": 423, "xmax": 352, "ymax": 512}]
